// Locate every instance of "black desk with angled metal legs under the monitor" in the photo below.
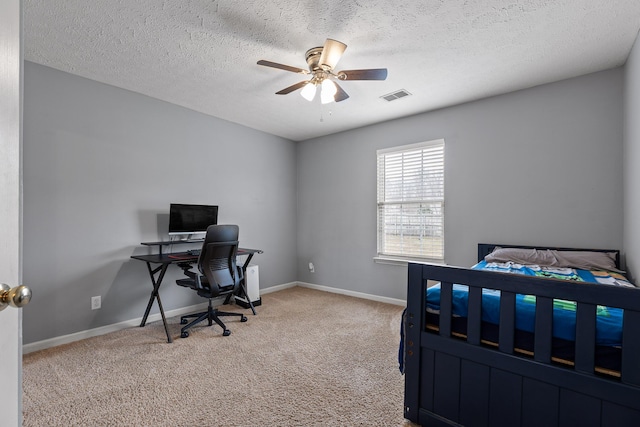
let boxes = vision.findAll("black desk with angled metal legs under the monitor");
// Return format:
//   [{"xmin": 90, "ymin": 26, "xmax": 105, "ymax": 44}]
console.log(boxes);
[{"xmin": 131, "ymin": 246, "xmax": 262, "ymax": 342}]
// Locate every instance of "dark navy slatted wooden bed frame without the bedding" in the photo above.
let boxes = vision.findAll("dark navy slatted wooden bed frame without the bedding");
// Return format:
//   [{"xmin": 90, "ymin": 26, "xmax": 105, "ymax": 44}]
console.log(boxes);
[{"xmin": 403, "ymin": 244, "xmax": 640, "ymax": 427}]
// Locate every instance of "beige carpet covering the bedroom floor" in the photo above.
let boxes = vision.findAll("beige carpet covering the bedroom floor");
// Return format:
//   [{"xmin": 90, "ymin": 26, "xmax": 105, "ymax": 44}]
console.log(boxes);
[{"xmin": 23, "ymin": 287, "xmax": 413, "ymax": 426}]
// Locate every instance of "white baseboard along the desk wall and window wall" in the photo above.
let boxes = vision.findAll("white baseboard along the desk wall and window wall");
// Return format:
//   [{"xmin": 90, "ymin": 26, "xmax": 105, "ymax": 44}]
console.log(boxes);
[{"xmin": 22, "ymin": 282, "xmax": 406, "ymax": 354}]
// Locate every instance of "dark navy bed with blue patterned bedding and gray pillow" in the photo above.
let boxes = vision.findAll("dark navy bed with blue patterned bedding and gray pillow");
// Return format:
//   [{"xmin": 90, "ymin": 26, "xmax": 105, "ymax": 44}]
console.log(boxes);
[{"xmin": 399, "ymin": 244, "xmax": 640, "ymax": 427}]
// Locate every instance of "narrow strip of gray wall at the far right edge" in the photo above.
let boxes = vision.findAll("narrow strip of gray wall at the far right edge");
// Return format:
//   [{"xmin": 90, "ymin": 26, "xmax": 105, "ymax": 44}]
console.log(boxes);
[{"xmin": 623, "ymin": 30, "xmax": 640, "ymax": 282}]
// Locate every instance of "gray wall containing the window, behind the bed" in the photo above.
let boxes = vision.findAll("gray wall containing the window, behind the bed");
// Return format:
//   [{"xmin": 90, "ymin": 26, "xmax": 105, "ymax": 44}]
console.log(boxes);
[{"xmin": 297, "ymin": 69, "xmax": 623, "ymax": 298}]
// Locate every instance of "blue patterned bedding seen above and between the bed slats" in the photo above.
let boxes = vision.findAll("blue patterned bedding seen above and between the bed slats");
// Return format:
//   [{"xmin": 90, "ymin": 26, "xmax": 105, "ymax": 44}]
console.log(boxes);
[{"xmin": 427, "ymin": 261, "xmax": 633, "ymax": 346}]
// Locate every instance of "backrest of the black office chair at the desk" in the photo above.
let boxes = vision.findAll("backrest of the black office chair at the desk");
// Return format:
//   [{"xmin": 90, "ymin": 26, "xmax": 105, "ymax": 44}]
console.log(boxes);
[{"xmin": 198, "ymin": 225, "xmax": 242, "ymax": 295}]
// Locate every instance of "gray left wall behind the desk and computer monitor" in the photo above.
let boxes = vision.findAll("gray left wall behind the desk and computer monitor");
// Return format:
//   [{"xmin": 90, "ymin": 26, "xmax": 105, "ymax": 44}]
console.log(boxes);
[{"xmin": 23, "ymin": 62, "xmax": 296, "ymax": 343}]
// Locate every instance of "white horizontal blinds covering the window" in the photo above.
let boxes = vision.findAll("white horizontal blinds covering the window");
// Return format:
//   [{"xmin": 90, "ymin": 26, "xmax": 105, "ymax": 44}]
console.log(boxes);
[{"xmin": 378, "ymin": 139, "xmax": 444, "ymax": 260}]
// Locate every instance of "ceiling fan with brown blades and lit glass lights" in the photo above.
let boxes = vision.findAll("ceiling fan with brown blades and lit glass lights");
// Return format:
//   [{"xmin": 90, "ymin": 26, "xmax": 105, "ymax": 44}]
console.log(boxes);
[{"xmin": 258, "ymin": 39, "xmax": 387, "ymax": 104}]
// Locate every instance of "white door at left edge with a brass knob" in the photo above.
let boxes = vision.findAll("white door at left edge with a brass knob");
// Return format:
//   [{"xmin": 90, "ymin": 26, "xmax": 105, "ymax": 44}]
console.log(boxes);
[{"xmin": 0, "ymin": 0, "xmax": 22, "ymax": 426}]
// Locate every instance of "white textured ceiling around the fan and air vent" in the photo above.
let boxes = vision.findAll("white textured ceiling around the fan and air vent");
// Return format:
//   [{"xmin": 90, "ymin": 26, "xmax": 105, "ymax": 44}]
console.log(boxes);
[{"xmin": 23, "ymin": 0, "xmax": 640, "ymax": 141}]
